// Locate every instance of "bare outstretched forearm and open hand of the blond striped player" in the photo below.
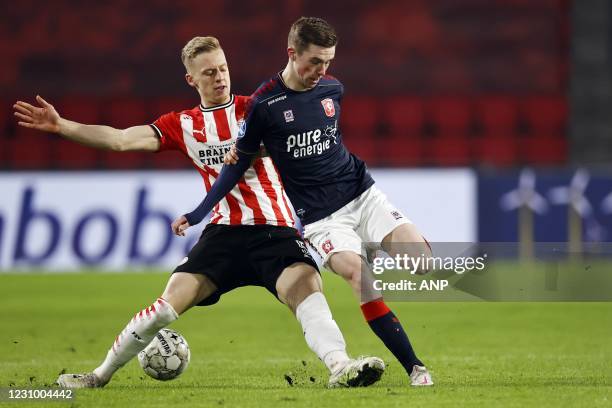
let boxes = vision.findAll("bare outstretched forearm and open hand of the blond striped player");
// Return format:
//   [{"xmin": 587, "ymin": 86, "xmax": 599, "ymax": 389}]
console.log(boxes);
[{"xmin": 13, "ymin": 95, "xmax": 160, "ymax": 151}]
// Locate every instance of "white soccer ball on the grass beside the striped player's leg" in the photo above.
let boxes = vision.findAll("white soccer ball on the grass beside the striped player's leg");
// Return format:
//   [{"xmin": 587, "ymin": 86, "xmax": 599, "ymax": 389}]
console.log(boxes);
[{"xmin": 138, "ymin": 329, "xmax": 191, "ymax": 381}]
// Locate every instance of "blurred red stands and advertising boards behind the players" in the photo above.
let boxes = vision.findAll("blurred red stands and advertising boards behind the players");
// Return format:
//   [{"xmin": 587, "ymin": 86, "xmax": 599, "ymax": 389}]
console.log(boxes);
[{"xmin": 0, "ymin": 0, "xmax": 612, "ymax": 269}]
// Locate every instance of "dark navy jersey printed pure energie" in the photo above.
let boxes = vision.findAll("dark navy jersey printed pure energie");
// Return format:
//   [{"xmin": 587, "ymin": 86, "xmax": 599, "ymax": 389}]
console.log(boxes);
[{"xmin": 236, "ymin": 74, "xmax": 374, "ymax": 224}]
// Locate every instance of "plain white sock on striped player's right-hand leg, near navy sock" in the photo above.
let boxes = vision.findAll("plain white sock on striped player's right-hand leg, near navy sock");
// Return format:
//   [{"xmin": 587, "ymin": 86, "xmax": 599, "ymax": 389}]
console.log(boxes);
[{"xmin": 295, "ymin": 292, "xmax": 349, "ymax": 372}]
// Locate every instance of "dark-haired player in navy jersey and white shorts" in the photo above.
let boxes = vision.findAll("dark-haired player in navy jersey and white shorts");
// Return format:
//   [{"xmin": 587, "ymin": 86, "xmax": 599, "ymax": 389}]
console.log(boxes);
[{"xmin": 173, "ymin": 17, "xmax": 433, "ymax": 386}]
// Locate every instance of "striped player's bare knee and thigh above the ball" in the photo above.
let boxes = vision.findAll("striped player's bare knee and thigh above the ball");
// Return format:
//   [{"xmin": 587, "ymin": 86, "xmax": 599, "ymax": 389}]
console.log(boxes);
[{"xmin": 162, "ymin": 272, "xmax": 217, "ymax": 314}]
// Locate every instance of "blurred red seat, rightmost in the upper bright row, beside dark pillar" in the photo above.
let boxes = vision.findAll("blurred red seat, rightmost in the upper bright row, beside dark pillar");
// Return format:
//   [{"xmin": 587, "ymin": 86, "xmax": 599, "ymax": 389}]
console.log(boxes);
[{"xmin": 521, "ymin": 96, "xmax": 568, "ymax": 136}]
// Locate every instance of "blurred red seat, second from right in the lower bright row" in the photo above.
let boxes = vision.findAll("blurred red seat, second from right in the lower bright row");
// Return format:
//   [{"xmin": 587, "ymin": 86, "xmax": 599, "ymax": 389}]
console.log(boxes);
[{"xmin": 471, "ymin": 133, "xmax": 518, "ymax": 167}]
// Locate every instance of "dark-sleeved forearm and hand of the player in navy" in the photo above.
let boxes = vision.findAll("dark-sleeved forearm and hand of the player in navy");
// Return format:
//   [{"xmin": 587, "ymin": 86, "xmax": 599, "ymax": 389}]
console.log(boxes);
[{"xmin": 172, "ymin": 151, "xmax": 254, "ymax": 235}]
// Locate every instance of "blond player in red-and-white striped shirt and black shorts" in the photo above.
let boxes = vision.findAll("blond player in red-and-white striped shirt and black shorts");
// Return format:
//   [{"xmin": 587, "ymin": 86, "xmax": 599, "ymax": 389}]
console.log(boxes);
[{"xmin": 14, "ymin": 37, "xmax": 384, "ymax": 388}]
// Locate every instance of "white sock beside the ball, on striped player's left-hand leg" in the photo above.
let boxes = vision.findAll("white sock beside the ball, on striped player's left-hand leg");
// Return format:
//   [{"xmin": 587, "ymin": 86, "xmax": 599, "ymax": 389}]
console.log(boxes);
[{"xmin": 94, "ymin": 298, "xmax": 178, "ymax": 383}]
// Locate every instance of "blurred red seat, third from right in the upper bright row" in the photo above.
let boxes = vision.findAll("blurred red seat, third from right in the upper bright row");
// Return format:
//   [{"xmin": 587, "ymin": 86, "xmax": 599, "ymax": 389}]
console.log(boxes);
[{"xmin": 427, "ymin": 97, "xmax": 472, "ymax": 138}]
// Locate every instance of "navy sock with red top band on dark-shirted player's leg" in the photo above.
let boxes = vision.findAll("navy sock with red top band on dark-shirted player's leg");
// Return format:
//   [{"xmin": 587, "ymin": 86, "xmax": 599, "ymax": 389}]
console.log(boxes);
[{"xmin": 361, "ymin": 300, "xmax": 424, "ymax": 375}]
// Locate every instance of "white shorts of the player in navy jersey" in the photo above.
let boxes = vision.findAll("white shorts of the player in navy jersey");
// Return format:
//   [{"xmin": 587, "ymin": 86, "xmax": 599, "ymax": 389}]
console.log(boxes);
[{"xmin": 304, "ymin": 186, "xmax": 412, "ymax": 266}]
